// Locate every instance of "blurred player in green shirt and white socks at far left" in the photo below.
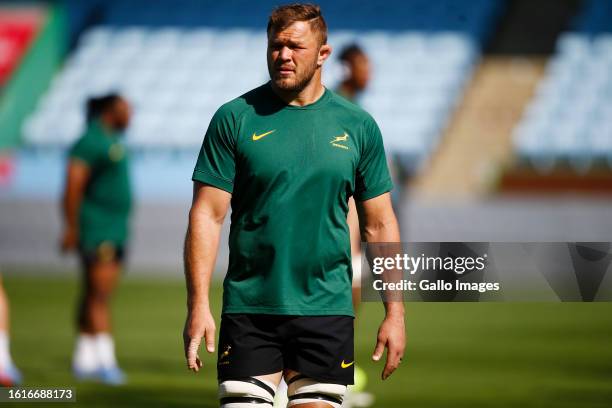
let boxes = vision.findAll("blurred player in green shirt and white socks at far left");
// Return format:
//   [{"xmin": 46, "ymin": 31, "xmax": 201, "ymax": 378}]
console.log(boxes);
[{"xmin": 62, "ymin": 94, "xmax": 131, "ymax": 384}]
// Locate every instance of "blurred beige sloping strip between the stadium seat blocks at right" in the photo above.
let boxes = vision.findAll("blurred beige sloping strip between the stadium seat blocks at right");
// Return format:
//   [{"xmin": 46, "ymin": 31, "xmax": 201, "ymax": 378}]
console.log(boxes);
[{"xmin": 410, "ymin": 55, "xmax": 546, "ymax": 201}]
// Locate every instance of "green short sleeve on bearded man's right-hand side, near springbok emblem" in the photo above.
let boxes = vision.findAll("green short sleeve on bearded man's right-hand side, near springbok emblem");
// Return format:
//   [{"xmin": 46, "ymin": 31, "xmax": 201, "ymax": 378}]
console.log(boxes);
[{"xmin": 354, "ymin": 118, "xmax": 393, "ymax": 201}]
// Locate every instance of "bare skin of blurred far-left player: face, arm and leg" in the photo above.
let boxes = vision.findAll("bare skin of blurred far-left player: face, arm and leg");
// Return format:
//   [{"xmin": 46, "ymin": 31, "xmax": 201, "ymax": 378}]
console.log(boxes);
[{"xmin": 61, "ymin": 100, "xmax": 131, "ymax": 334}]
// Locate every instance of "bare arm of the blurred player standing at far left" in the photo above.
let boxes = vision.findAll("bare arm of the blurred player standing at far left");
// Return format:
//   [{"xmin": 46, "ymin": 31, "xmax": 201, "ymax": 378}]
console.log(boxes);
[{"xmin": 61, "ymin": 159, "xmax": 90, "ymax": 251}]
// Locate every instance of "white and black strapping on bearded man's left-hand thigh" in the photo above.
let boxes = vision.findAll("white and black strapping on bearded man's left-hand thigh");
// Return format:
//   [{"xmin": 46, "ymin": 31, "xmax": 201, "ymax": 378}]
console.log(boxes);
[{"xmin": 219, "ymin": 379, "xmax": 276, "ymax": 408}]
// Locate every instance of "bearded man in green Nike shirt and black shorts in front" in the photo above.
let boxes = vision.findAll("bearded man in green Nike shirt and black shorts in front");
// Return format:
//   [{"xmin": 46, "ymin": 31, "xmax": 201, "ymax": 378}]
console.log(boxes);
[{"xmin": 183, "ymin": 5, "xmax": 405, "ymax": 408}]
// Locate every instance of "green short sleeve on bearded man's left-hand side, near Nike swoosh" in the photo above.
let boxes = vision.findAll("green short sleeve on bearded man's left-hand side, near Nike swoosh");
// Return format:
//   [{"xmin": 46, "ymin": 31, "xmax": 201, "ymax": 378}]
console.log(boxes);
[{"xmin": 192, "ymin": 107, "xmax": 236, "ymax": 193}]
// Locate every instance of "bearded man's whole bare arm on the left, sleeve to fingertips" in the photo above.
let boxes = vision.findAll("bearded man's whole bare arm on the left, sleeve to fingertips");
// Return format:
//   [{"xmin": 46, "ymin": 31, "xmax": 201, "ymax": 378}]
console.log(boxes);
[{"xmin": 183, "ymin": 182, "xmax": 232, "ymax": 372}]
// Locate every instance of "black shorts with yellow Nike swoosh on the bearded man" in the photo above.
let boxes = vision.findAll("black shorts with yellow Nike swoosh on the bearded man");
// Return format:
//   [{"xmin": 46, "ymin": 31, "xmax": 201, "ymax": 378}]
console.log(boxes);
[{"xmin": 217, "ymin": 313, "xmax": 355, "ymax": 385}]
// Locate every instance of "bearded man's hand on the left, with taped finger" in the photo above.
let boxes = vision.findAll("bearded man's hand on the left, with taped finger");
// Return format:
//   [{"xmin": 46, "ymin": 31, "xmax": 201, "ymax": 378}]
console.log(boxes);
[{"xmin": 183, "ymin": 308, "xmax": 216, "ymax": 373}]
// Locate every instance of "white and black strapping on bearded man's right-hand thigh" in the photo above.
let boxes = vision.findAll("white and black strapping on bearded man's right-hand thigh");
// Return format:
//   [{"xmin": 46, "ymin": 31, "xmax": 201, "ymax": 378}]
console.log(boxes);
[{"xmin": 287, "ymin": 378, "xmax": 346, "ymax": 408}]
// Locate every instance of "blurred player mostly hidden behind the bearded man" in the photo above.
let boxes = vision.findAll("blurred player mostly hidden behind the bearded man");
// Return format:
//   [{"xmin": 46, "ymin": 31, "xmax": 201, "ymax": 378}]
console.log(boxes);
[{"xmin": 336, "ymin": 44, "xmax": 374, "ymax": 407}]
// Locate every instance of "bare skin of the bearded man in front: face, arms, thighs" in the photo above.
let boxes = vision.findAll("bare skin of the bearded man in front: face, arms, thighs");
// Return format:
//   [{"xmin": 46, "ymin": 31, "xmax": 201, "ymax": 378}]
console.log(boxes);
[{"xmin": 183, "ymin": 22, "xmax": 405, "ymax": 408}]
